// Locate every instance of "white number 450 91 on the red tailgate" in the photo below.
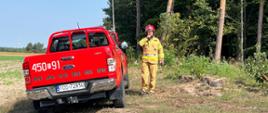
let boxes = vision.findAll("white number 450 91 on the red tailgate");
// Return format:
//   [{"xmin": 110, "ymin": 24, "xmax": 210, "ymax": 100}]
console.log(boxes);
[{"xmin": 32, "ymin": 60, "xmax": 60, "ymax": 72}]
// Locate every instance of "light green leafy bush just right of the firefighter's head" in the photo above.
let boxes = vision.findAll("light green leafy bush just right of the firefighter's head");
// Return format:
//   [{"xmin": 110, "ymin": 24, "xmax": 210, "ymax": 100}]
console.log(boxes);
[{"xmin": 158, "ymin": 13, "xmax": 197, "ymax": 57}]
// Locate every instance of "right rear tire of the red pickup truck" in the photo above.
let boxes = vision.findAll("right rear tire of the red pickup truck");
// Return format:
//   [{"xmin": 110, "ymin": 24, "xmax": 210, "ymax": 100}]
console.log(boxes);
[{"xmin": 113, "ymin": 69, "xmax": 125, "ymax": 108}]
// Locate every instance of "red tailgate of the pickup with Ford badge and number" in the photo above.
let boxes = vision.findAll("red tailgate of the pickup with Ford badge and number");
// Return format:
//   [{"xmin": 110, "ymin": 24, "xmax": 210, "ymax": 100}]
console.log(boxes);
[{"xmin": 29, "ymin": 46, "xmax": 112, "ymax": 88}]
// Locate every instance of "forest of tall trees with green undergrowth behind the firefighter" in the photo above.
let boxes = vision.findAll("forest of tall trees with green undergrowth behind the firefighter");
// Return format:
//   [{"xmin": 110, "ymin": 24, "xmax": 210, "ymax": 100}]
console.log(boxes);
[{"xmin": 103, "ymin": 0, "xmax": 268, "ymax": 83}]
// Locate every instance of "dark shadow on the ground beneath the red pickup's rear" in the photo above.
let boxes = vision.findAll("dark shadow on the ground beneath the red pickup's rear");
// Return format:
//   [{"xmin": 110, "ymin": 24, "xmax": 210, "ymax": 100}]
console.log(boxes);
[{"xmin": 7, "ymin": 100, "xmax": 113, "ymax": 113}]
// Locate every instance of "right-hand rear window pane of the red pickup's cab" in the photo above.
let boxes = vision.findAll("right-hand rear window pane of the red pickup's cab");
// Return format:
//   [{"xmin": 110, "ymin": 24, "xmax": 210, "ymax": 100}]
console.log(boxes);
[{"xmin": 88, "ymin": 33, "xmax": 108, "ymax": 47}]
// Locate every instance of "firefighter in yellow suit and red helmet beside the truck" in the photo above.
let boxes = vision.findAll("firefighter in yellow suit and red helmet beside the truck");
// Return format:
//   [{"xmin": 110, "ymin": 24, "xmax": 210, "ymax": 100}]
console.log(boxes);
[{"xmin": 138, "ymin": 24, "xmax": 164, "ymax": 94}]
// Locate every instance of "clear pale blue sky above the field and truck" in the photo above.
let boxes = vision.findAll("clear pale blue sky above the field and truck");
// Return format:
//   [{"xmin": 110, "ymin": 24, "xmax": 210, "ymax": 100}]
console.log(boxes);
[{"xmin": 0, "ymin": 0, "xmax": 108, "ymax": 48}]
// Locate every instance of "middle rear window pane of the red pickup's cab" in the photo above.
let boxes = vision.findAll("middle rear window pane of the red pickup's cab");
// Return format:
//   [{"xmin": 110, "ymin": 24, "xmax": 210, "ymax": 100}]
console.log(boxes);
[{"xmin": 72, "ymin": 33, "xmax": 87, "ymax": 50}]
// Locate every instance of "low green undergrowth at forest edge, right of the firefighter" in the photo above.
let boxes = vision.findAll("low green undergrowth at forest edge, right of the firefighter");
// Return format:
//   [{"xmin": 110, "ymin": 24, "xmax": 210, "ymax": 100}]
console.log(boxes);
[{"xmin": 168, "ymin": 55, "xmax": 245, "ymax": 79}]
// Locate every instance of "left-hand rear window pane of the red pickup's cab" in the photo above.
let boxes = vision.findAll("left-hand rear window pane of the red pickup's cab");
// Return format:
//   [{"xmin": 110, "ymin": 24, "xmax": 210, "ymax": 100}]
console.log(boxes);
[{"xmin": 50, "ymin": 37, "xmax": 70, "ymax": 52}]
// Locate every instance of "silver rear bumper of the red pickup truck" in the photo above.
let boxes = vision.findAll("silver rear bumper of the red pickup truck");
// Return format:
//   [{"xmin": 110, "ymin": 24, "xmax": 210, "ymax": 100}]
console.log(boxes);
[{"xmin": 27, "ymin": 78, "xmax": 116, "ymax": 100}]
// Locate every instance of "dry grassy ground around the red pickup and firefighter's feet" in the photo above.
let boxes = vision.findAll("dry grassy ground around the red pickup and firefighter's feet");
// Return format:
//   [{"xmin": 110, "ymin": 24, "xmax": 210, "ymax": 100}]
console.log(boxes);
[{"xmin": 0, "ymin": 52, "xmax": 268, "ymax": 113}]
